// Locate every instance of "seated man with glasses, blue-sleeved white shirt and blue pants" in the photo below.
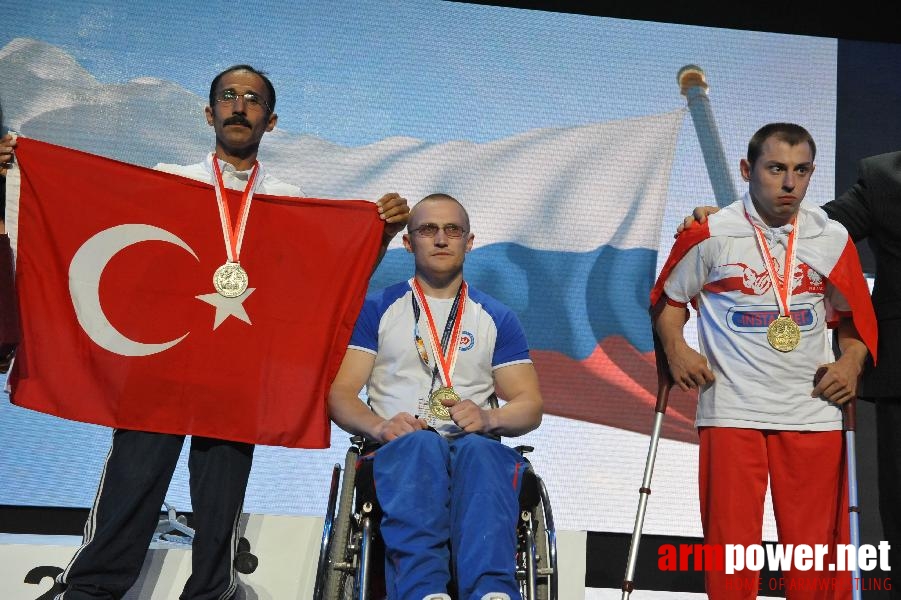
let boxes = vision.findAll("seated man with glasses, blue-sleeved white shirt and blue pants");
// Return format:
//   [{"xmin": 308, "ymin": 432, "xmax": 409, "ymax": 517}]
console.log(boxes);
[{"xmin": 329, "ymin": 194, "xmax": 542, "ymax": 600}]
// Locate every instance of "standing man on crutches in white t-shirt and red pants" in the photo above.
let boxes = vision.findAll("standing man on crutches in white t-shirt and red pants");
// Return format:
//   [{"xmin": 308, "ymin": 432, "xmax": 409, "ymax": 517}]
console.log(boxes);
[{"xmin": 651, "ymin": 123, "xmax": 876, "ymax": 599}]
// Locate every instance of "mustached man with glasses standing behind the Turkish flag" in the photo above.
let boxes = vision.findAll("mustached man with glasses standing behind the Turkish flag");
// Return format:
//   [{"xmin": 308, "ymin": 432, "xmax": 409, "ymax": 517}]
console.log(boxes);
[{"xmin": 0, "ymin": 65, "xmax": 409, "ymax": 600}]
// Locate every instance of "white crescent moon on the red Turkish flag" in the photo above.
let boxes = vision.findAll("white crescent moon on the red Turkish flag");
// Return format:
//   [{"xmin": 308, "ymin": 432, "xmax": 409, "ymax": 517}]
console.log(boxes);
[{"xmin": 69, "ymin": 224, "xmax": 199, "ymax": 356}]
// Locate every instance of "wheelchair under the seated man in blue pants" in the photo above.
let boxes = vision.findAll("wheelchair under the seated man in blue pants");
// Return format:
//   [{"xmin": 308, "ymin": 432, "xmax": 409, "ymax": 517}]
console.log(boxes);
[{"xmin": 313, "ymin": 436, "xmax": 557, "ymax": 600}]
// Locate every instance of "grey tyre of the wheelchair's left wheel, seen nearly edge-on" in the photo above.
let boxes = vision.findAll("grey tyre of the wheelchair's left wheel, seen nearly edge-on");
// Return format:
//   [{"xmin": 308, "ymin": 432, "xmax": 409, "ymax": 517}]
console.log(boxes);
[{"xmin": 323, "ymin": 448, "xmax": 359, "ymax": 600}]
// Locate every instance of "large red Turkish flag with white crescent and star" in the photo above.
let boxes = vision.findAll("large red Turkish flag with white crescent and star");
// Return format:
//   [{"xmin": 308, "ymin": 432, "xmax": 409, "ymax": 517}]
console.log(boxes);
[{"xmin": 7, "ymin": 138, "xmax": 383, "ymax": 448}]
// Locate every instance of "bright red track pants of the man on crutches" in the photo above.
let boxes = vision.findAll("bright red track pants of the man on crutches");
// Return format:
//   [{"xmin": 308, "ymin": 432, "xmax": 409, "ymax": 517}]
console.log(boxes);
[{"xmin": 698, "ymin": 427, "xmax": 852, "ymax": 600}]
